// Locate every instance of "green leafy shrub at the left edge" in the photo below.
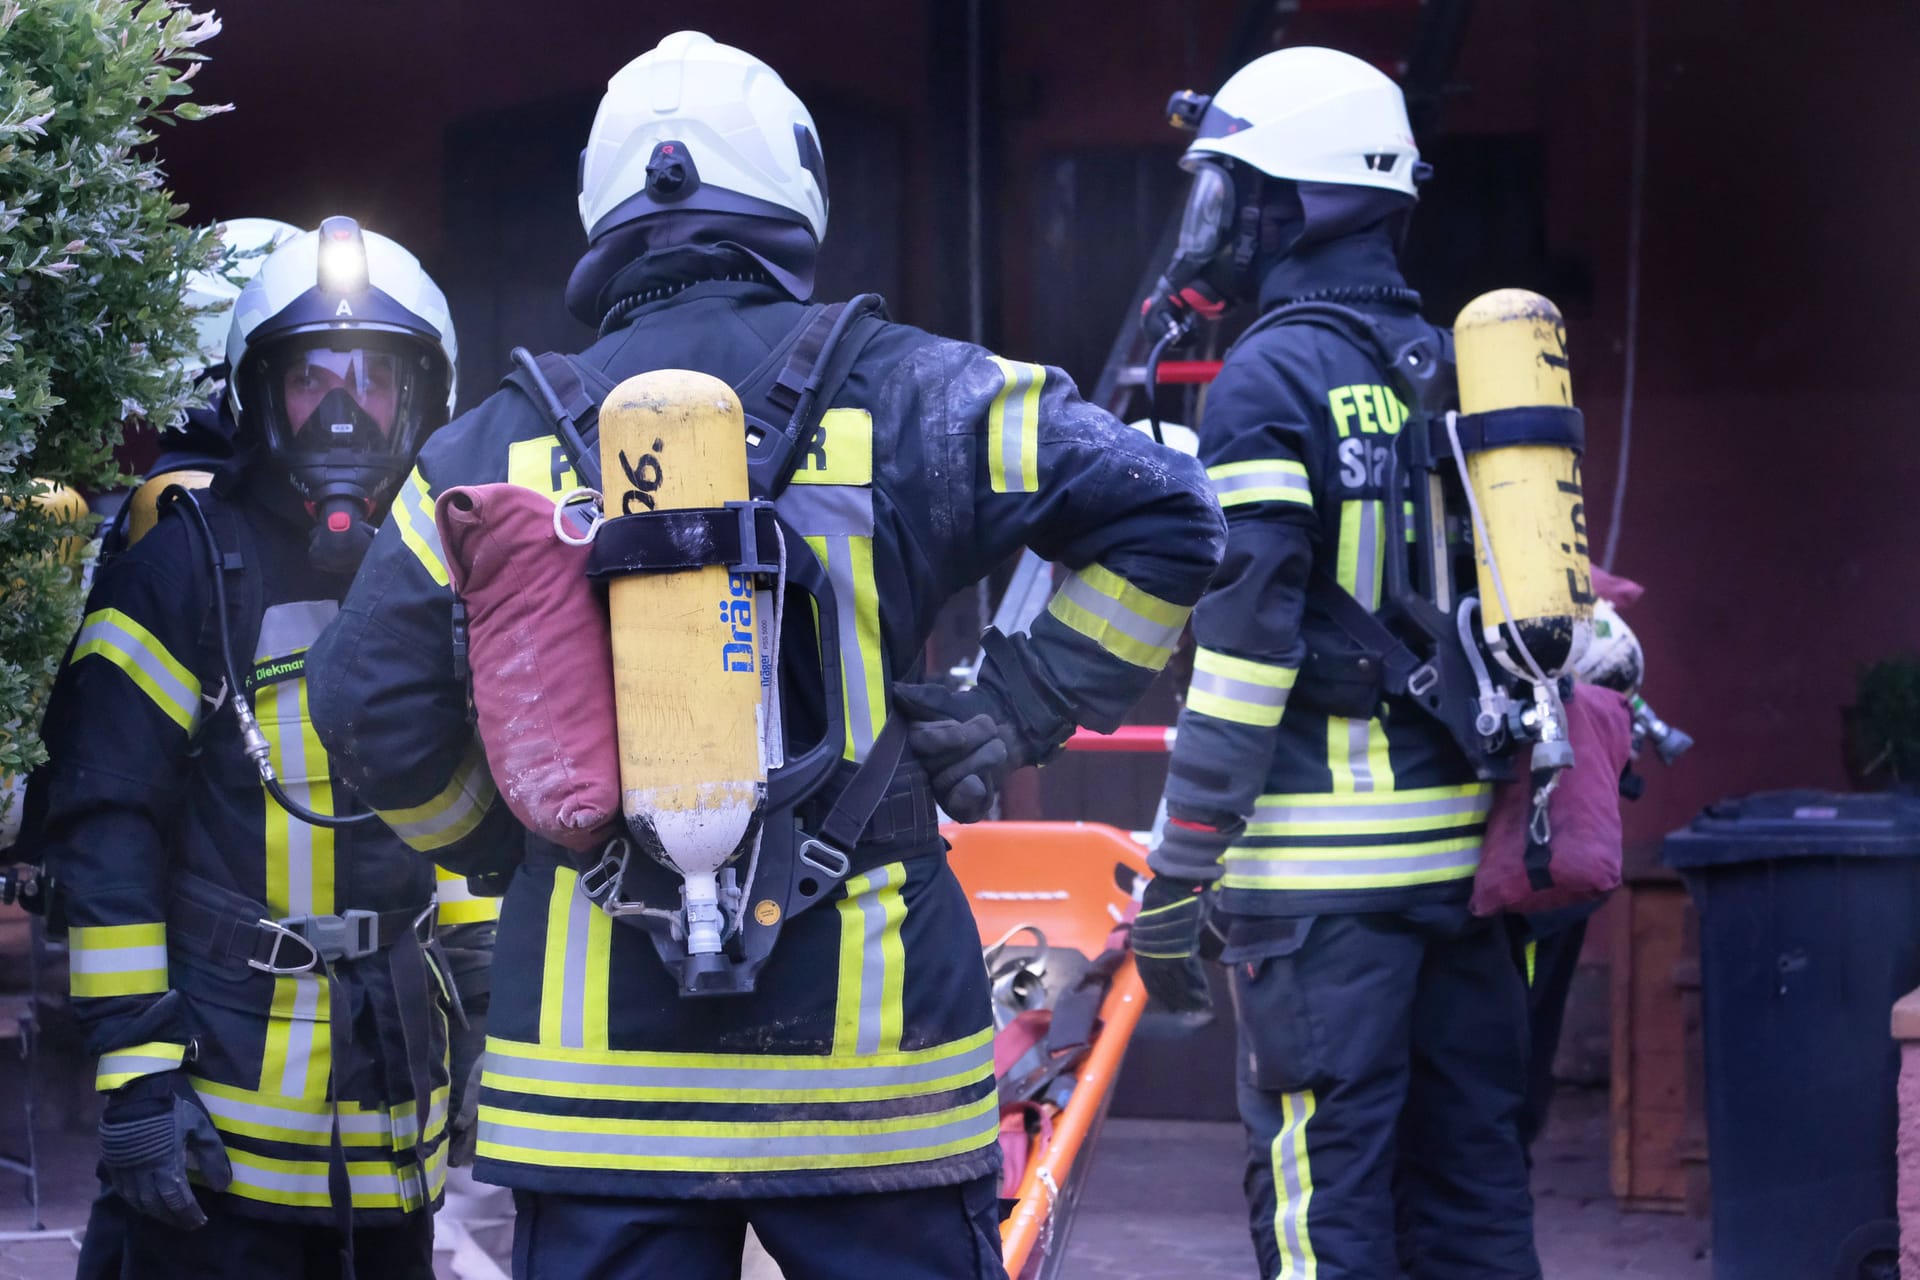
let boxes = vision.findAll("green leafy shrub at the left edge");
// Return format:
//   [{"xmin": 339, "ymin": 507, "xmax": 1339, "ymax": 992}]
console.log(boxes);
[{"xmin": 0, "ymin": 0, "xmax": 225, "ymax": 816}]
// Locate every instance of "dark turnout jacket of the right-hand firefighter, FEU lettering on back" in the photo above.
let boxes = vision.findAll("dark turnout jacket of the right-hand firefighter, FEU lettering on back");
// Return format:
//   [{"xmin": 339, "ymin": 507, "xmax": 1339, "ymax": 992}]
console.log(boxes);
[{"xmin": 1152, "ymin": 232, "xmax": 1490, "ymax": 915}]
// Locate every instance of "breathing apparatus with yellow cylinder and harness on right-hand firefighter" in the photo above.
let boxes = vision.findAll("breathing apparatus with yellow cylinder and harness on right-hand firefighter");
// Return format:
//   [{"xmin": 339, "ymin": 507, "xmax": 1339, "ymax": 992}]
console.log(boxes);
[{"xmin": 1235, "ymin": 290, "xmax": 1594, "ymax": 790}]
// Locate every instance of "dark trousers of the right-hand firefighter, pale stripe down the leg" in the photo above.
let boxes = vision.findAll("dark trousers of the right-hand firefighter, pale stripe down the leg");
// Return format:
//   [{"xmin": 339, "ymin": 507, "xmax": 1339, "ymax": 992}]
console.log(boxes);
[{"xmin": 1221, "ymin": 904, "xmax": 1540, "ymax": 1280}]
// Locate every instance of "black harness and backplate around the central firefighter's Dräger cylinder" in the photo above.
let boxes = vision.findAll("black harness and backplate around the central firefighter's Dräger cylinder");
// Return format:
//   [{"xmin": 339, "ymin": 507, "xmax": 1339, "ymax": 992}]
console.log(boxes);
[{"xmin": 482, "ymin": 294, "xmax": 904, "ymax": 996}]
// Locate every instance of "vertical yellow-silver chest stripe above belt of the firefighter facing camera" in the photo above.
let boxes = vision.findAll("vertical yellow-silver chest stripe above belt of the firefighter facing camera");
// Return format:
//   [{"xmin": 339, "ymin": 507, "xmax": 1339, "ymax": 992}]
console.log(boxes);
[{"xmin": 253, "ymin": 677, "xmax": 334, "ymax": 919}]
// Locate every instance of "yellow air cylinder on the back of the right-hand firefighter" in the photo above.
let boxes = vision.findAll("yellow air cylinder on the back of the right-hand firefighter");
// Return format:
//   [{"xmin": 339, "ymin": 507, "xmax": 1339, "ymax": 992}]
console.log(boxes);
[{"xmin": 1453, "ymin": 290, "xmax": 1594, "ymax": 676}]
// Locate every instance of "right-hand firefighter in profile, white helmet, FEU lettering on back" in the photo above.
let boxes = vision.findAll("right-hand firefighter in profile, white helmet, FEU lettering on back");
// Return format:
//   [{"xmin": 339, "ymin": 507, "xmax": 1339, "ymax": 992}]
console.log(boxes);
[{"xmin": 1135, "ymin": 48, "xmax": 1540, "ymax": 1280}]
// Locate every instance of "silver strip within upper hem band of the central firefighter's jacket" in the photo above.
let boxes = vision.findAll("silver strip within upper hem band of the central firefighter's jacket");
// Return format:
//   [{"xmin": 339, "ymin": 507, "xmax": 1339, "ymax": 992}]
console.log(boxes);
[{"xmin": 486, "ymin": 1036, "xmax": 993, "ymax": 1094}]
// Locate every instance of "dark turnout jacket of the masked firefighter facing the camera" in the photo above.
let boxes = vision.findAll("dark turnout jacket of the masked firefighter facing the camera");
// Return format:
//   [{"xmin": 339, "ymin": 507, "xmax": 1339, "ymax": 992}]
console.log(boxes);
[{"xmin": 33, "ymin": 474, "xmax": 447, "ymax": 1224}]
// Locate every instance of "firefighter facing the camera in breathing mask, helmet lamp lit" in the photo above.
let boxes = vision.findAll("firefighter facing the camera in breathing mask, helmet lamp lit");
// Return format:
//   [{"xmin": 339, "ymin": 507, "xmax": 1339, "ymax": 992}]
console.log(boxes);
[{"xmin": 35, "ymin": 219, "xmax": 455, "ymax": 1280}]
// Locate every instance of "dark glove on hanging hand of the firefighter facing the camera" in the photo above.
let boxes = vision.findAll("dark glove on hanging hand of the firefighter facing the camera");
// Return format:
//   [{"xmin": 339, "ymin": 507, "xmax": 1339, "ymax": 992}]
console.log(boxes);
[{"xmin": 100, "ymin": 1071, "xmax": 234, "ymax": 1230}]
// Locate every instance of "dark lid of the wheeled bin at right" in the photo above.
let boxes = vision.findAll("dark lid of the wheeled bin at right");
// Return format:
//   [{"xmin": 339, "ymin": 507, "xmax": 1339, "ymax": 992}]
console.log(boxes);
[{"xmin": 1661, "ymin": 791, "xmax": 1920, "ymax": 871}]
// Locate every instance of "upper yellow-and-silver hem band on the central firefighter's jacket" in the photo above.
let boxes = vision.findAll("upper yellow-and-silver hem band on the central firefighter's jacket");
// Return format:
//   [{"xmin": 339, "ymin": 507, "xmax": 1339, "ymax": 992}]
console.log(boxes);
[{"xmin": 486, "ymin": 1027, "xmax": 993, "ymax": 1105}]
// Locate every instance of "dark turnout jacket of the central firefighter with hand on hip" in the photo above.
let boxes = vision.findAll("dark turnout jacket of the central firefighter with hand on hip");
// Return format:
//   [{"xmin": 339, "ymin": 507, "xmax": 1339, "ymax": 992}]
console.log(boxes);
[{"xmin": 311, "ymin": 259, "xmax": 1221, "ymax": 1197}]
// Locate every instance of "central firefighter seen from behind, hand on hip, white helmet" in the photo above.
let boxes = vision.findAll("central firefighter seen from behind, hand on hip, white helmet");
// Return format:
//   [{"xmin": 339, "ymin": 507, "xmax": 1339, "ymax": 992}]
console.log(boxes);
[{"xmin": 309, "ymin": 33, "xmax": 1221, "ymax": 1280}]
